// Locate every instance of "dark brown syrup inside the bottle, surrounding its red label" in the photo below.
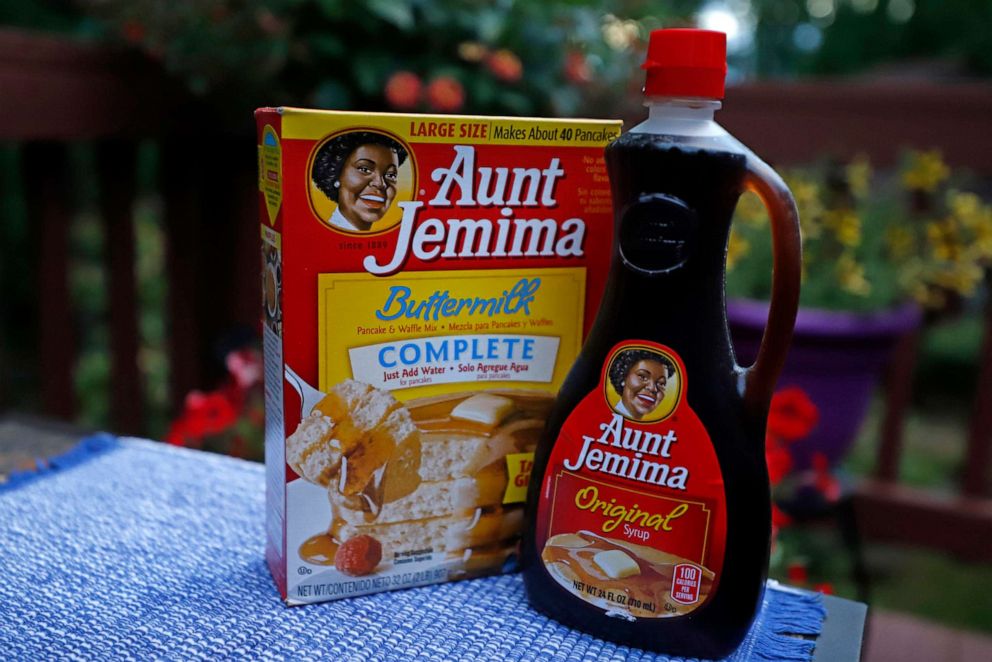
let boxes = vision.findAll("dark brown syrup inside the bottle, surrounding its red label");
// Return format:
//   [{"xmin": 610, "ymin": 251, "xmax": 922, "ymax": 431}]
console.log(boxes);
[{"xmin": 521, "ymin": 133, "xmax": 771, "ymax": 658}]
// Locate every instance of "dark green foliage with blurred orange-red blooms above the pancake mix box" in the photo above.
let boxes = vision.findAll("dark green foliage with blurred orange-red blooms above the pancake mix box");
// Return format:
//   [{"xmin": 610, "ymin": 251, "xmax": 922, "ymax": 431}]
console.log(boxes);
[{"xmin": 71, "ymin": 0, "xmax": 699, "ymax": 116}]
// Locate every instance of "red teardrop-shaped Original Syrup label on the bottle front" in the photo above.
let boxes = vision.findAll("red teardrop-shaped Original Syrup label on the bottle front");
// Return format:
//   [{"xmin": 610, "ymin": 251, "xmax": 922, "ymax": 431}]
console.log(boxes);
[{"xmin": 536, "ymin": 340, "xmax": 727, "ymax": 620}]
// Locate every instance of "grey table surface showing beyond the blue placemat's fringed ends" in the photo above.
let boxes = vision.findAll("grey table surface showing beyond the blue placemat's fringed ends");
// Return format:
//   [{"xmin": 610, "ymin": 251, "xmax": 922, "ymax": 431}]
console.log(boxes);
[{"xmin": 0, "ymin": 415, "xmax": 868, "ymax": 662}]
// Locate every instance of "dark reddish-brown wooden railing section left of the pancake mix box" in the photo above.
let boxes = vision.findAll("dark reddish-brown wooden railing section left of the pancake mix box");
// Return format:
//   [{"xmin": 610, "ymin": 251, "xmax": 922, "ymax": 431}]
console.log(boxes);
[{"xmin": 0, "ymin": 29, "xmax": 260, "ymax": 434}]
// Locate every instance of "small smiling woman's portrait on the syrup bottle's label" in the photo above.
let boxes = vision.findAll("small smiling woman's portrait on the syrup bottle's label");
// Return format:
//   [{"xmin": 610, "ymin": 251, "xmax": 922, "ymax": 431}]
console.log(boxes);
[{"xmin": 609, "ymin": 349, "xmax": 675, "ymax": 421}]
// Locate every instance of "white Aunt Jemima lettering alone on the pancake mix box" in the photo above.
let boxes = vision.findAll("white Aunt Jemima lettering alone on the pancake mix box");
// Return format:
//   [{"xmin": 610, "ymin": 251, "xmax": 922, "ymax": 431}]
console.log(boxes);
[{"xmin": 362, "ymin": 145, "xmax": 586, "ymax": 276}]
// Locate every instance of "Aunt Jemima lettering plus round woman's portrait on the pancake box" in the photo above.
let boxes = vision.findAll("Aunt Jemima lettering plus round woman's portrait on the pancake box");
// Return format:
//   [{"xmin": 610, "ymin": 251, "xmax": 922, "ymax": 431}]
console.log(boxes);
[{"xmin": 311, "ymin": 130, "xmax": 586, "ymax": 276}]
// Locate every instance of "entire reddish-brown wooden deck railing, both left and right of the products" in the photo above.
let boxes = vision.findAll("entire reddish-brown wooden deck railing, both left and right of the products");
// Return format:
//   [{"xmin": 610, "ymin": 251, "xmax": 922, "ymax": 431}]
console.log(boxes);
[{"xmin": 0, "ymin": 31, "xmax": 992, "ymax": 560}]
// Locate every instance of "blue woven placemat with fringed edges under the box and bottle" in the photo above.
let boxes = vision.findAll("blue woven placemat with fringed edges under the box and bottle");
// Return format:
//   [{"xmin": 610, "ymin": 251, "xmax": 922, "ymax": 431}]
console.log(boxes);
[{"xmin": 0, "ymin": 436, "xmax": 824, "ymax": 660}]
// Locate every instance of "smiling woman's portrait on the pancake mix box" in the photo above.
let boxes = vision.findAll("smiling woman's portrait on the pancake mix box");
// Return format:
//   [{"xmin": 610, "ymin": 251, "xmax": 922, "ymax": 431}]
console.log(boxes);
[{"xmin": 312, "ymin": 131, "xmax": 407, "ymax": 232}]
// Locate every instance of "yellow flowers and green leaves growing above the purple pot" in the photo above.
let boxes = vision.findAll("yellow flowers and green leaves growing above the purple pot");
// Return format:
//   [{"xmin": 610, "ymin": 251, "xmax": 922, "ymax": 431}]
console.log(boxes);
[{"xmin": 727, "ymin": 152, "xmax": 992, "ymax": 312}]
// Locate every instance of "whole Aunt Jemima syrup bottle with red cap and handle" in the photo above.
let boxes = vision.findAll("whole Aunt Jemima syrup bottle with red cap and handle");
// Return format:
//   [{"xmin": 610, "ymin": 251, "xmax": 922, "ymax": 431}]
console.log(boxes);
[{"xmin": 521, "ymin": 30, "xmax": 800, "ymax": 658}]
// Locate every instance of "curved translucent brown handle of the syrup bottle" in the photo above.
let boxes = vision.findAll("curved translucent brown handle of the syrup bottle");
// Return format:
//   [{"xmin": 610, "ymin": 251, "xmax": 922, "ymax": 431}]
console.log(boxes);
[{"xmin": 743, "ymin": 154, "xmax": 802, "ymax": 417}]
